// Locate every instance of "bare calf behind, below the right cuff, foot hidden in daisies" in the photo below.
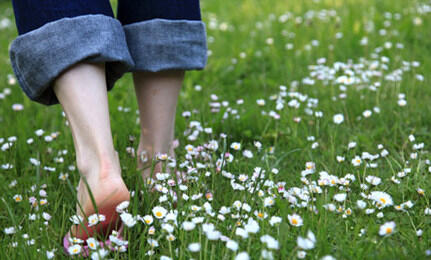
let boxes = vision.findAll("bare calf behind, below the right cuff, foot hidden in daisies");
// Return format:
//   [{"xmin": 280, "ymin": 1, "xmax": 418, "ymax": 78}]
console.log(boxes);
[{"xmin": 133, "ymin": 70, "xmax": 184, "ymax": 179}]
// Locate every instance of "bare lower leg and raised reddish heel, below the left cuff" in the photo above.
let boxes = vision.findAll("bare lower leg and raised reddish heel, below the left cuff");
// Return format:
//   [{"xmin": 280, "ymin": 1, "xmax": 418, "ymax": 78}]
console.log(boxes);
[{"xmin": 53, "ymin": 63, "xmax": 129, "ymax": 238}]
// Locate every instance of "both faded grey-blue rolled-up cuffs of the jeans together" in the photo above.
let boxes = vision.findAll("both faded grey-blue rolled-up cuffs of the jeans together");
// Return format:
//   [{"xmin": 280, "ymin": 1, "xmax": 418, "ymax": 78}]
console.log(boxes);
[{"xmin": 9, "ymin": 14, "xmax": 207, "ymax": 105}]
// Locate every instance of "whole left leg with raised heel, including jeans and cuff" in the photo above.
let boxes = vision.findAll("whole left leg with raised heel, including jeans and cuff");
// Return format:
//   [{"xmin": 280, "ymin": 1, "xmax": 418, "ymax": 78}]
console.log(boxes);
[{"xmin": 10, "ymin": 0, "xmax": 134, "ymax": 241}]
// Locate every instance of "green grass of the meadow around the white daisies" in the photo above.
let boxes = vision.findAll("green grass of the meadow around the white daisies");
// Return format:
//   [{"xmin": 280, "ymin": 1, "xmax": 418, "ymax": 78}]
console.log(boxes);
[{"xmin": 0, "ymin": 0, "xmax": 431, "ymax": 259}]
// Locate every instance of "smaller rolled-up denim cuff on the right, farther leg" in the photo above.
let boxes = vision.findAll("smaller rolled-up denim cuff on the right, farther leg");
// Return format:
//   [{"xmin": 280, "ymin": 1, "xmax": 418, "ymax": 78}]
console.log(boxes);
[{"xmin": 123, "ymin": 19, "xmax": 207, "ymax": 72}]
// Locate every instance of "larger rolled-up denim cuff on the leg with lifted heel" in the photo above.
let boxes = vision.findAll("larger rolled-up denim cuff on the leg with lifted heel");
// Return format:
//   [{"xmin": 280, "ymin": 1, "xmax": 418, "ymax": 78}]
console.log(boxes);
[{"xmin": 9, "ymin": 14, "xmax": 134, "ymax": 105}]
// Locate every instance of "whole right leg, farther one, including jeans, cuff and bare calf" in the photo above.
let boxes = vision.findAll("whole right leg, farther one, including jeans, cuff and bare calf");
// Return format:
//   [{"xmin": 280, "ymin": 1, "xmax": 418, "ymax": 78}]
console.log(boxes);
[{"xmin": 118, "ymin": 0, "xmax": 207, "ymax": 182}]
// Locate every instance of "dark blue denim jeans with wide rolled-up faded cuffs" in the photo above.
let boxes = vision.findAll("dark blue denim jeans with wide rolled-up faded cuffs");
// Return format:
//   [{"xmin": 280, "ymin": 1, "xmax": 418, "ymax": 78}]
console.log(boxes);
[{"xmin": 9, "ymin": 0, "xmax": 207, "ymax": 105}]
